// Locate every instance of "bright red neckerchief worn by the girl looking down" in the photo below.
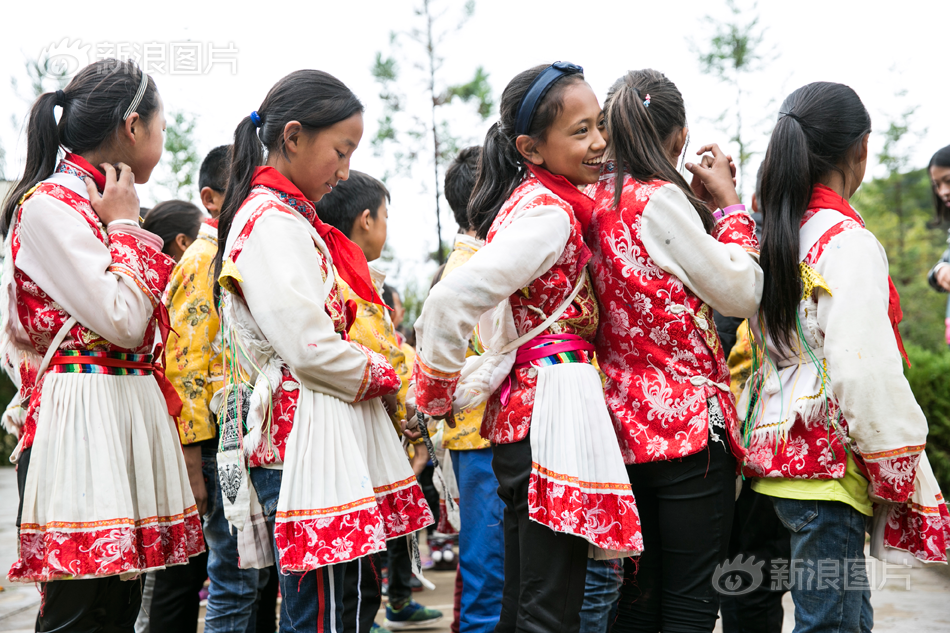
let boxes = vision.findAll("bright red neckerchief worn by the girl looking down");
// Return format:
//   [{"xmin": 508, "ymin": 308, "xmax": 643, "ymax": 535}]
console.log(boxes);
[{"xmin": 251, "ymin": 167, "xmax": 385, "ymax": 305}]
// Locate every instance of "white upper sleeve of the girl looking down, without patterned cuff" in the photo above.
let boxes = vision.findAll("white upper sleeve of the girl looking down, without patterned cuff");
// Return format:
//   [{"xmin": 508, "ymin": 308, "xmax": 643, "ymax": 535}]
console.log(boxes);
[{"xmin": 236, "ymin": 212, "xmax": 368, "ymax": 402}]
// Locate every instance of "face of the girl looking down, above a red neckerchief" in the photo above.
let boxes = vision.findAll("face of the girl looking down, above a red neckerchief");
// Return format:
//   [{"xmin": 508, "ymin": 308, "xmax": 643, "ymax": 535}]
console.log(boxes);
[{"xmin": 285, "ymin": 113, "xmax": 363, "ymax": 202}]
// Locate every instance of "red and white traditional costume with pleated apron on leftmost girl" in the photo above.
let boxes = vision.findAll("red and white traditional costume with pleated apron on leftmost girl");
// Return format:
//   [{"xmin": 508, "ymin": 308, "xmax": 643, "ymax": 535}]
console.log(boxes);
[{"xmin": 2, "ymin": 154, "xmax": 204, "ymax": 621}]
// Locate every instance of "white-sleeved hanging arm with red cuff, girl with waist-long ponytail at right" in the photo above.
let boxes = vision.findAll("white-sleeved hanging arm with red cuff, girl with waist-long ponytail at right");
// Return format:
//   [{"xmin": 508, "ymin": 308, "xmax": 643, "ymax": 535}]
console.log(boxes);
[{"xmin": 817, "ymin": 230, "xmax": 927, "ymax": 502}]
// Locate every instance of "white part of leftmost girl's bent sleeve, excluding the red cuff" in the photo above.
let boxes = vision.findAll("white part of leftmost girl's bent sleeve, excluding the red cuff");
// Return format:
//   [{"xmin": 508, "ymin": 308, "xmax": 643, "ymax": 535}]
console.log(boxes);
[{"xmin": 16, "ymin": 195, "xmax": 155, "ymax": 349}]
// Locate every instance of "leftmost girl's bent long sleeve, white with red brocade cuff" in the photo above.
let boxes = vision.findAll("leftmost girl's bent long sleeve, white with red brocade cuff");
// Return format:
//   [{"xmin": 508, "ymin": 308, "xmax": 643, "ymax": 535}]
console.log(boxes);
[{"xmin": 16, "ymin": 195, "xmax": 174, "ymax": 349}]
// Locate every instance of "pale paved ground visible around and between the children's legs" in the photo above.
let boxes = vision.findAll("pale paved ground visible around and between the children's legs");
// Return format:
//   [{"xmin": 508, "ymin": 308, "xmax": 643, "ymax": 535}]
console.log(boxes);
[{"xmin": 0, "ymin": 467, "xmax": 950, "ymax": 633}]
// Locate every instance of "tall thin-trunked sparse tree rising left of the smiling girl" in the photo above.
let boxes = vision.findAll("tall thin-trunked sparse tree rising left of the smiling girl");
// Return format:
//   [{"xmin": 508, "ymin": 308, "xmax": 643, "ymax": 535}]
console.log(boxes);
[{"xmin": 372, "ymin": 0, "xmax": 494, "ymax": 263}]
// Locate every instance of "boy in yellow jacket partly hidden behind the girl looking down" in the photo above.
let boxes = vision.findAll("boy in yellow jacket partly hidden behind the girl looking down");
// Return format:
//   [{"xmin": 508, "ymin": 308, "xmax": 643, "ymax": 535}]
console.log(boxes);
[{"xmin": 315, "ymin": 170, "xmax": 442, "ymax": 633}]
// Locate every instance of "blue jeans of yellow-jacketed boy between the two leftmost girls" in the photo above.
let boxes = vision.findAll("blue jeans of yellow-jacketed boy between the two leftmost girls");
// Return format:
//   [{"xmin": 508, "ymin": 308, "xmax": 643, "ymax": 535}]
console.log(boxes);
[{"xmin": 201, "ymin": 451, "xmax": 269, "ymax": 633}]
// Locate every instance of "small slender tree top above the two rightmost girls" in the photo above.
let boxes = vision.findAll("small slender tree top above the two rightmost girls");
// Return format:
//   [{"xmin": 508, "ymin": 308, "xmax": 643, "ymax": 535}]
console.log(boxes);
[{"xmin": 691, "ymin": 0, "xmax": 777, "ymax": 198}]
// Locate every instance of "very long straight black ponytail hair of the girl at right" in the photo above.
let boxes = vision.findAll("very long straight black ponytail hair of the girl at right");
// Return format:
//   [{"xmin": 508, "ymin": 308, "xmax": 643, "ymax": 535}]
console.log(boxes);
[{"xmin": 759, "ymin": 82, "xmax": 871, "ymax": 349}]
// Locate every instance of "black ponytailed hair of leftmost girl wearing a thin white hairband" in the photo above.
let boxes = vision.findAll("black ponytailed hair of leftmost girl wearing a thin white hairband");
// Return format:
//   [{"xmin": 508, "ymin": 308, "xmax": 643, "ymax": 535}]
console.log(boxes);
[{"xmin": 0, "ymin": 59, "xmax": 158, "ymax": 235}]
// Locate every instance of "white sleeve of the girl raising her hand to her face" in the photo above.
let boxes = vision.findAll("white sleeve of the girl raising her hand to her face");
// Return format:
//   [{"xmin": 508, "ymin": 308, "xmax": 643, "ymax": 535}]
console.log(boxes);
[{"xmin": 640, "ymin": 185, "xmax": 763, "ymax": 318}]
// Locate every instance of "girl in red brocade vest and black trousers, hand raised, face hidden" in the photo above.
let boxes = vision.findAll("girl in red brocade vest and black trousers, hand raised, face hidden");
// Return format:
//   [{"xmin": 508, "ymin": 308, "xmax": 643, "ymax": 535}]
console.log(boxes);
[{"xmin": 587, "ymin": 70, "xmax": 762, "ymax": 631}]
